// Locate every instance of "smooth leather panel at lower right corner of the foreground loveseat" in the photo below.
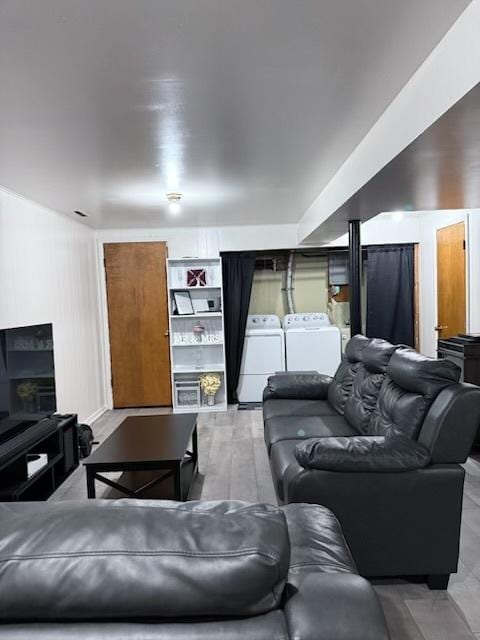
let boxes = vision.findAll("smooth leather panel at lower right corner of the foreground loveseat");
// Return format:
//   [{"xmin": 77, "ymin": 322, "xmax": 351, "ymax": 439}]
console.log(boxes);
[{"xmin": 284, "ymin": 573, "xmax": 390, "ymax": 640}]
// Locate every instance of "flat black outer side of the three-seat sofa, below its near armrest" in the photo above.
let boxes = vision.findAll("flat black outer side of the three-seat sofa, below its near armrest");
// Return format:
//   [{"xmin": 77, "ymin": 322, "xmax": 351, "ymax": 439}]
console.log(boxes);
[{"xmin": 282, "ymin": 460, "xmax": 465, "ymax": 576}]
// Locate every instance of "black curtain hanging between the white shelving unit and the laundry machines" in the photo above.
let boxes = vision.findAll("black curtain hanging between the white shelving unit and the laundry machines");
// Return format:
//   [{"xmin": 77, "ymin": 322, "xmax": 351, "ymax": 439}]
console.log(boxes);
[{"xmin": 222, "ymin": 252, "xmax": 256, "ymax": 403}]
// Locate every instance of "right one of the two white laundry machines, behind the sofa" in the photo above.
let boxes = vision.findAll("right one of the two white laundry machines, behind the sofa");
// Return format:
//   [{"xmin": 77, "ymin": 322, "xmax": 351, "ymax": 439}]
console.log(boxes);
[{"xmin": 283, "ymin": 313, "xmax": 342, "ymax": 376}]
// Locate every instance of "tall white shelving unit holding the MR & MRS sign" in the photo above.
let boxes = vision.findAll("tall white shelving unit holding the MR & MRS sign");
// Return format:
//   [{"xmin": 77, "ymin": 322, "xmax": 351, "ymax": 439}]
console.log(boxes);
[{"xmin": 167, "ymin": 258, "xmax": 227, "ymax": 413}]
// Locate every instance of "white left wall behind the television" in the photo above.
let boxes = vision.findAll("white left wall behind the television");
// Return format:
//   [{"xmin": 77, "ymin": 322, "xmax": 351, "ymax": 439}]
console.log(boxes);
[{"xmin": 0, "ymin": 189, "xmax": 105, "ymax": 420}]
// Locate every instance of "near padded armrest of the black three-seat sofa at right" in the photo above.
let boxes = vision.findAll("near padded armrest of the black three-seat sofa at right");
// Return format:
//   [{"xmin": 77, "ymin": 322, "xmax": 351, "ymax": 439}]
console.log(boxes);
[{"xmin": 295, "ymin": 435, "xmax": 430, "ymax": 473}]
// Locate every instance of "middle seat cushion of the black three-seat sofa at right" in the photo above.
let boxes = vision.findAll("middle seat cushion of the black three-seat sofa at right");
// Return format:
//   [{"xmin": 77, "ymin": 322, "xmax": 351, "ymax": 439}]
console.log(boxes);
[{"xmin": 265, "ymin": 414, "xmax": 358, "ymax": 450}]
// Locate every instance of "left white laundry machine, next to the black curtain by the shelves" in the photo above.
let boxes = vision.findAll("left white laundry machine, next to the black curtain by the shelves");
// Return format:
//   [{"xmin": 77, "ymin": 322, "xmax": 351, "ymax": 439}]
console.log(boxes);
[{"xmin": 237, "ymin": 315, "xmax": 285, "ymax": 402}]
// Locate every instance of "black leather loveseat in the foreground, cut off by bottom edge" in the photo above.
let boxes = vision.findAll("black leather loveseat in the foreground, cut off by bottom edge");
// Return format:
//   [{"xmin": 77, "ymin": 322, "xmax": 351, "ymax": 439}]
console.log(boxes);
[{"xmin": 0, "ymin": 500, "xmax": 389, "ymax": 640}]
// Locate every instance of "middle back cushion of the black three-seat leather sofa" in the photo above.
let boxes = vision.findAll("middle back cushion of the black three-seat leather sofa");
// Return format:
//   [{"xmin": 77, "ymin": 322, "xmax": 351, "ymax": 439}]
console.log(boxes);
[{"xmin": 345, "ymin": 338, "xmax": 398, "ymax": 434}]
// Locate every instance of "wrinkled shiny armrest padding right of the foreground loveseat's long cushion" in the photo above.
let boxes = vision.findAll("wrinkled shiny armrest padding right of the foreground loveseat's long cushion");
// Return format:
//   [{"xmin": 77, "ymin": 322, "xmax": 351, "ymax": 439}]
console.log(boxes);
[{"xmin": 282, "ymin": 502, "xmax": 357, "ymax": 584}]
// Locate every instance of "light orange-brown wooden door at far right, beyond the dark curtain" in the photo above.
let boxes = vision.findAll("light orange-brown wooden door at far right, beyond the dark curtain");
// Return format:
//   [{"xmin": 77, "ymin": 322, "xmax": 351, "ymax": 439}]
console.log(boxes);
[{"xmin": 435, "ymin": 222, "xmax": 467, "ymax": 338}]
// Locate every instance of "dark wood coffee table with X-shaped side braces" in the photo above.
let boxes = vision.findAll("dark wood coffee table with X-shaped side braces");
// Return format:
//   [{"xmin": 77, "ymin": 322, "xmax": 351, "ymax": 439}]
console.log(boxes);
[{"xmin": 83, "ymin": 413, "xmax": 198, "ymax": 500}]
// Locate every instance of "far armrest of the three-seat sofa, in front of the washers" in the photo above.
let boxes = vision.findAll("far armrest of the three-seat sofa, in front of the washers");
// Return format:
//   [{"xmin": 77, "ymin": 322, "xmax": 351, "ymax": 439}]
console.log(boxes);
[{"xmin": 263, "ymin": 372, "xmax": 333, "ymax": 402}]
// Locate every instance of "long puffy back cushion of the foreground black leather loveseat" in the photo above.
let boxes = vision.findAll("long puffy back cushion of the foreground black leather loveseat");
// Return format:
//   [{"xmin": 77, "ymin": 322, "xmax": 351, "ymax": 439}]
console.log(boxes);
[{"xmin": 0, "ymin": 500, "xmax": 290, "ymax": 622}]
